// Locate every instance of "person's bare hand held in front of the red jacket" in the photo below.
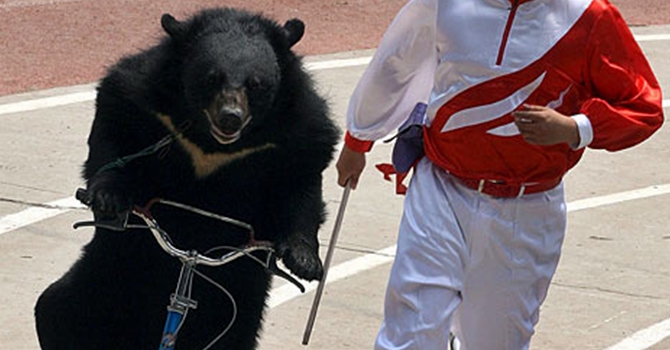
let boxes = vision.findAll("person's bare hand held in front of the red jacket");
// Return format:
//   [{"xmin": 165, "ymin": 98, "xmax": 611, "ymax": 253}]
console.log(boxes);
[{"xmin": 512, "ymin": 105, "xmax": 579, "ymax": 146}]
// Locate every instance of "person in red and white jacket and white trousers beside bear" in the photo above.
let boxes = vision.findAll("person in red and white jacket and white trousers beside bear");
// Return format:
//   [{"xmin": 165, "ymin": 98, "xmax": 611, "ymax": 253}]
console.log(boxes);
[{"xmin": 337, "ymin": 0, "xmax": 663, "ymax": 350}]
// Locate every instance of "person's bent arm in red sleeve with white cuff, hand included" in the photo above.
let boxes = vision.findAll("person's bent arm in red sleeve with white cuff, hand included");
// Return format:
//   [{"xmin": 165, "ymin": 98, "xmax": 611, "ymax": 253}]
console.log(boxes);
[{"xmin": 513, "ymin": 7, "xmax": 663, "ymax": 151}]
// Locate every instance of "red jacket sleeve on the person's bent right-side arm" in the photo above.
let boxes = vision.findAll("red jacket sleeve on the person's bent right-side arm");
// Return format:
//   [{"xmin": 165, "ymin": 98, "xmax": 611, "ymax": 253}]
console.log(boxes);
[{"xmin": 581, "ymin": 6, "xmax": 663, "ymax": 151}]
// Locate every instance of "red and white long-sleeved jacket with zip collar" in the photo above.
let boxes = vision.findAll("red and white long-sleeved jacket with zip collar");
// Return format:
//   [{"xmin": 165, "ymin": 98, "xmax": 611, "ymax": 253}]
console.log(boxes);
[{"xmin": 345, "ymin": 0, "xmax": 663, "ymax": 184}]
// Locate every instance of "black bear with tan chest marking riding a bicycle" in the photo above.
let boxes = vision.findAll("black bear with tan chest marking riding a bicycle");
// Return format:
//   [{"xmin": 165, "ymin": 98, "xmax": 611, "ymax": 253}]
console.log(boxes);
[{"xmin": 35, "ymin": 8, "xmax": 340, "ymax": 350}]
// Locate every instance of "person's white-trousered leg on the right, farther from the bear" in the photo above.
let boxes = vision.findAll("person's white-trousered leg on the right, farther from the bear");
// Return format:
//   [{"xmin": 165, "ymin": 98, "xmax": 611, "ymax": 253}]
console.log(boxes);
[{"xmin": 452, "ymin": 185, "xmax": 566, "ymax": 350}]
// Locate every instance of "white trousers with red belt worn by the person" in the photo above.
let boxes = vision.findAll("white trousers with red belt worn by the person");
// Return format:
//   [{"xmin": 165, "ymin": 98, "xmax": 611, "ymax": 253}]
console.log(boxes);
[{"xmin": 375, "ymin": 158, "xmax": 566, "ymax": 350}]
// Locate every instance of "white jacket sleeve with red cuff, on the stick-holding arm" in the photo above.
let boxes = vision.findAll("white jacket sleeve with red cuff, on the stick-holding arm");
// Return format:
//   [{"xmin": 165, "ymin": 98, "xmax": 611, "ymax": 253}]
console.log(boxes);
[{"xmin": 345, "ymin": 0, "xmax": 438, "ymax": 152}]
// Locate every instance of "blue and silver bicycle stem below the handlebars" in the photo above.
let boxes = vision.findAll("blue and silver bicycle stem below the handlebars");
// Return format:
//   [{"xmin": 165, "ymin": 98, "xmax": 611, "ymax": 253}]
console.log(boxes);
[{"xmin": 158, "ymin": 252, "xmax": 198, "ymax": 350}]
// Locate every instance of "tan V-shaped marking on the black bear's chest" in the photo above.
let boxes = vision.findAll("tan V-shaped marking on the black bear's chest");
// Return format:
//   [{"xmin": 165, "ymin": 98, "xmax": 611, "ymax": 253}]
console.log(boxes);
[{"xmin": 157, "ymin": 114, "xmax": 277, "ymax": 179}]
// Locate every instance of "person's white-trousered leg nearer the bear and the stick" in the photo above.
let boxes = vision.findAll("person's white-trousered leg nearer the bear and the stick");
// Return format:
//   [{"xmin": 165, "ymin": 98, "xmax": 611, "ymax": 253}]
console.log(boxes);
[{"xmin": 375, "ymin": 159, "xmax": 468, "ymax": 350}]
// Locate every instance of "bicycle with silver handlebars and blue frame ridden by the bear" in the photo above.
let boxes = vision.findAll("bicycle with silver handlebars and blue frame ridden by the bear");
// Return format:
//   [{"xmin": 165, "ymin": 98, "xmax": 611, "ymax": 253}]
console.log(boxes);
[{"xmin": 73, "ymin": 188, "xmax": 305, "ymax": 350}]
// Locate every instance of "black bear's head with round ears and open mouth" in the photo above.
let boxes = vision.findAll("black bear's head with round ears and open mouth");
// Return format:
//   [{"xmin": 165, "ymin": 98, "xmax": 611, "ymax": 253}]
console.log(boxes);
[{"xmin": 161, "ymin": 9, "xmax": 304, "ymax": 145}]
